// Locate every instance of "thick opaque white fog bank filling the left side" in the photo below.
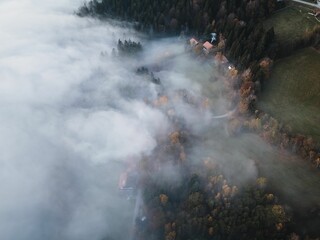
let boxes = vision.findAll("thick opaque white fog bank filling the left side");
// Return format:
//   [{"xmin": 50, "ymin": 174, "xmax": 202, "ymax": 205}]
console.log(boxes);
[{"xmin": 0, "ymin": 0, "xmax": 168, "ymax": 240}]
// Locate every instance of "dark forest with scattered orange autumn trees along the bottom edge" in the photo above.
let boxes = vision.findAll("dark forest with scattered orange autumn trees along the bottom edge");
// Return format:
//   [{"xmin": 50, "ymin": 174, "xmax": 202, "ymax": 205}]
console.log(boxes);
[{"xmin": 136, "ymin": 131, "xmax": 294, "ymax": 240}]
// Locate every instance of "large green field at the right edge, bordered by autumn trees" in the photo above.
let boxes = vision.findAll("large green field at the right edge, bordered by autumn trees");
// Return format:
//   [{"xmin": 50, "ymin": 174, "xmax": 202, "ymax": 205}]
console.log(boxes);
[{"xmin": 259, "ymin": 48, "xmax": 320, "ymax": 142}]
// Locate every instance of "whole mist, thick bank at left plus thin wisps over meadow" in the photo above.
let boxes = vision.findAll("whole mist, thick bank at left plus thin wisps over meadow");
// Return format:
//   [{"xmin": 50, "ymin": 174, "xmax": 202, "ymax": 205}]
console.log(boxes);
[{"xmin": 0, "ymin": 0, "xmax": 320, "ymax": 240}]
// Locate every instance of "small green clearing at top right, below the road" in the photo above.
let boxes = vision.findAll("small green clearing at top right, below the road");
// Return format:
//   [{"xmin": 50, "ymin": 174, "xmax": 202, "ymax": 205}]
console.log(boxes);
[{"xmin": 264, "ymin": 6, "xmax": 319, "ymax": 42}]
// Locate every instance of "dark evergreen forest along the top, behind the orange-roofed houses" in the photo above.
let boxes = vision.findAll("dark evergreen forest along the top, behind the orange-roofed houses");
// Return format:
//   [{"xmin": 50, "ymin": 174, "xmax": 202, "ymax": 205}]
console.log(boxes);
[{"xmin": 78, "ymin": 0, "xmax": 277, "ymax": 69}]
